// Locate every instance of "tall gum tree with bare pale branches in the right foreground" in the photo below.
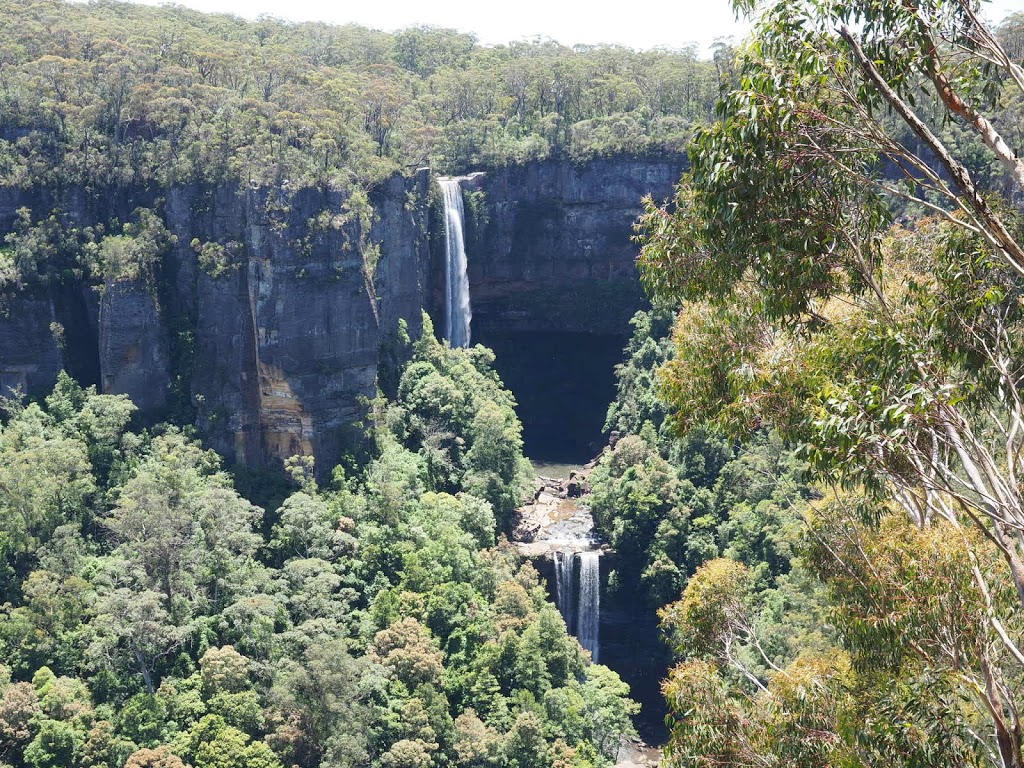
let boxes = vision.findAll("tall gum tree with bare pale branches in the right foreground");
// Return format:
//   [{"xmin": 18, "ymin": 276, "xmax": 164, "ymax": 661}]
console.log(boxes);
[{"xmin": 638, "ymin": 0, "xmax": 1024, "ymax": 767}]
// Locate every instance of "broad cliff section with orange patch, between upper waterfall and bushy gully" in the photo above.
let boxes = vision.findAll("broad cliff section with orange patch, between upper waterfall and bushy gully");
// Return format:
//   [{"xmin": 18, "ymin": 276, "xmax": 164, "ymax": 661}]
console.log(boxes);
[{"xmin": 173, "ymin": 172, "xmax": 427, "ymax": 471}]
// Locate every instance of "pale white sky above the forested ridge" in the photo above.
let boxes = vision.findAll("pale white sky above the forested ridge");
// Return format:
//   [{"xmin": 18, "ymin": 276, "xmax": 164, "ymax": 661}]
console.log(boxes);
[{"xmin": 123, "ymin": 0, "xmax": 1024, "ymax": 54}]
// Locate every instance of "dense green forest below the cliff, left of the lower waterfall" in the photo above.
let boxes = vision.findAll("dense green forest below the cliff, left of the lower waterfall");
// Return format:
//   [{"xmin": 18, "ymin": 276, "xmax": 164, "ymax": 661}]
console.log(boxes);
[{"xmin": 0, "ymin": 321, "xmax": 636, "ymax": 768}]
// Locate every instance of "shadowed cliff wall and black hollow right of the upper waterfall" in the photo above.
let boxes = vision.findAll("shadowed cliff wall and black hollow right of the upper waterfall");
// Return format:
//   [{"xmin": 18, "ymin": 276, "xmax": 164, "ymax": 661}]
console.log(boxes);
[{"xmin": 442, "ymin": 157, "xmax": 686, "ymax": 463}]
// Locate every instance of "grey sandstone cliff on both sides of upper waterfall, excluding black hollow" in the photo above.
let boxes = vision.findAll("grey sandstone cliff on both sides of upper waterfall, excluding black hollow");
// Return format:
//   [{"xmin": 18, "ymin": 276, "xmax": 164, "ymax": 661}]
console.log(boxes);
[{"xmin": 0, "ymin": 154, "xmax": 682, "ymax": 471}]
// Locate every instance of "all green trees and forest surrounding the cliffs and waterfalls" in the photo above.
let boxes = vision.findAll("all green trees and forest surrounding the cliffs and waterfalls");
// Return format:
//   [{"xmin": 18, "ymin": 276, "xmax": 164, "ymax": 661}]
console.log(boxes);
[{"xmin": 6, "ymin": 0, "xmax": 1024, "ymax": 768}]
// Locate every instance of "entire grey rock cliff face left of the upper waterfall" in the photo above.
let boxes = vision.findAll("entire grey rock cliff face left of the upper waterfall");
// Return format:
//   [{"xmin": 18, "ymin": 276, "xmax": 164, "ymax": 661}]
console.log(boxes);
[{"xmin": 0, "ymin": 171, "xmax": 428, "ymax": 470}]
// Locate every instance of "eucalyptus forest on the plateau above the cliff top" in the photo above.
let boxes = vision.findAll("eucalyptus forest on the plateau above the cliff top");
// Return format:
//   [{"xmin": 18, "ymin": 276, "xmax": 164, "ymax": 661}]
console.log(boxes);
[{"xmin": 0, "ymin": 0, "xmax": 728, "ymax": 189}]
